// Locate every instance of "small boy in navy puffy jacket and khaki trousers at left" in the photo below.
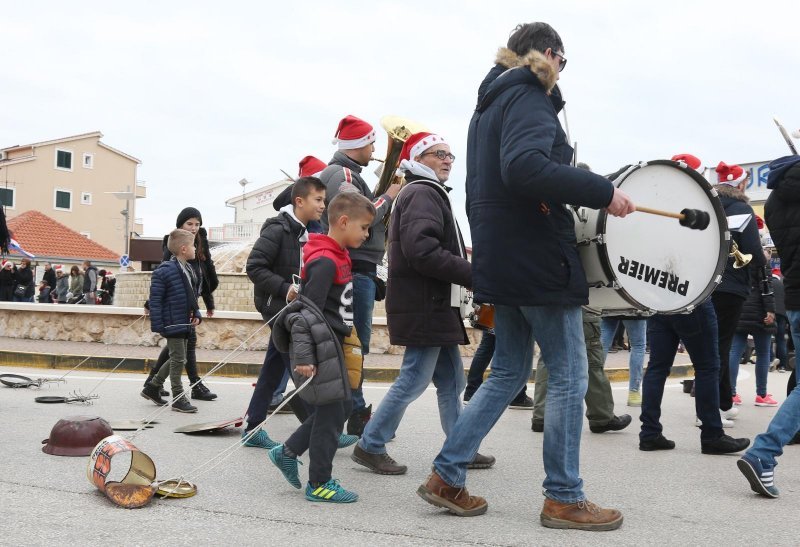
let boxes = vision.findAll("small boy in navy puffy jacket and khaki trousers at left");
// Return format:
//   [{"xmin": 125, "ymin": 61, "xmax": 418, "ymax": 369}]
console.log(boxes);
[{"xmin": 141, "ymin": 229, "xmax": 201, "ymax": 412}]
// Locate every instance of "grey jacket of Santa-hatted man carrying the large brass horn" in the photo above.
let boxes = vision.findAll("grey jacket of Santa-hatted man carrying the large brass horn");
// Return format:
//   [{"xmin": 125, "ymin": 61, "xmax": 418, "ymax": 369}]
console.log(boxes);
[{"xmin": 319, "ymin": 152, "xmax": 392, "ymax": 273}]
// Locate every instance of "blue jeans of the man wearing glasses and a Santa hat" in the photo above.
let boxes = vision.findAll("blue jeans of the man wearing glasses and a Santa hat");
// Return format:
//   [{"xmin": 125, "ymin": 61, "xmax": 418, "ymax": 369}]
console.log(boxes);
[{"xmin": 359, "ymin": 346, "xmax": 466, "ymax": 454}]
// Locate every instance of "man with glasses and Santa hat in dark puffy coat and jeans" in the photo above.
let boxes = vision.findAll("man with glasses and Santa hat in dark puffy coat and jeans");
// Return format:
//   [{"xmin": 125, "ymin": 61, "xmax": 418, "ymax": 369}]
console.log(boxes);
[{"xmin": 352, "ymin": 133, "xmax": 495, "ymax": 475}]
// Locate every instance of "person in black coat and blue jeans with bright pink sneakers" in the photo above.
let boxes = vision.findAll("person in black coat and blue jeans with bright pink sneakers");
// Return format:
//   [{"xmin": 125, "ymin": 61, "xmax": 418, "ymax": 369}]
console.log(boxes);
[{"xmin": 730, "ymin": 265, "xmax": 778, "ymax": 406}]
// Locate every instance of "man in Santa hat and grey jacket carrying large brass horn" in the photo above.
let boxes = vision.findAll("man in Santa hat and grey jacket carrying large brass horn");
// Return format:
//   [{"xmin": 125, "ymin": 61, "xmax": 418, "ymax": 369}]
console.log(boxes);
[{"xmin": 319, "ymin": 115, "xmax": 400, "ymax": 435}]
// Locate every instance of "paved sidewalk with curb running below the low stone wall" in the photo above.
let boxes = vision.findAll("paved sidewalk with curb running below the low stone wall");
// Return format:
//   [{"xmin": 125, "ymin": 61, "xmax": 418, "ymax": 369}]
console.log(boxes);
[{"xmin": 0, "ymin": 337, "xmax": 691, "ymax": 382}]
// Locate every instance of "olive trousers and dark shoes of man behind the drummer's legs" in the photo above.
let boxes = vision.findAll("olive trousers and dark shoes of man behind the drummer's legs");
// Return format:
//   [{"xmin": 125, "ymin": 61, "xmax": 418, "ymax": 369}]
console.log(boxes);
[{"xmin": 531, "ymin": 309, "xmax": 631, "ymax": 433}]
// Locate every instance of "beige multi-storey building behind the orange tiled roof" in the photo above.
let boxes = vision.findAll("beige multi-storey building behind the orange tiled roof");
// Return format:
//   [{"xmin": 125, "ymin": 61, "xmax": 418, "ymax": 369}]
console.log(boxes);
[{"xmin": 0, "ymin": 131, "xmax": 146, "ymax": 255}]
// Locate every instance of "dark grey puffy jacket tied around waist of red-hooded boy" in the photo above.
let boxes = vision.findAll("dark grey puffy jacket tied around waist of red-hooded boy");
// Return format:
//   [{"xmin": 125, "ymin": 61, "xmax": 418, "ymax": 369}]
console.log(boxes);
[{"xmin": 271, "ymin": 294, "xmax": 352, "ymax": 405}]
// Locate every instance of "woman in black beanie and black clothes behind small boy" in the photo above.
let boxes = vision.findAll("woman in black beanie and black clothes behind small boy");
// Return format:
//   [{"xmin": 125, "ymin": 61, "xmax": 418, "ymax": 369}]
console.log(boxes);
[{"xmin": 145, "ymin": 207, "xmax": 219, "ymax": 401}]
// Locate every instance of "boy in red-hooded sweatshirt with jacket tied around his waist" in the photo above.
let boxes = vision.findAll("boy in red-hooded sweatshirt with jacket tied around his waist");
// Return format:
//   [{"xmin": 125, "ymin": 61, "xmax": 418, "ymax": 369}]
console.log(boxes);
[{"xmin": 269, "ymin": 192, "xmax": 375, "ymax": 503}]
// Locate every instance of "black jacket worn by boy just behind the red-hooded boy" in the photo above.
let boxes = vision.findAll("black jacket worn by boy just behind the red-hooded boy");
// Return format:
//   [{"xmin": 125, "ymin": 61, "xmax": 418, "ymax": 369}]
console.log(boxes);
[{"xmin": 246, "ymin": 212, "xmax": 305, "ymax": 321}]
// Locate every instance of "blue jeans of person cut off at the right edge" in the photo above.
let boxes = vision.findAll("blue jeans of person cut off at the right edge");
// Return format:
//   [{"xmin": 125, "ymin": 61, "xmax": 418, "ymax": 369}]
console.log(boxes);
[{"xmin": 747, "ymin": 310, "xmax": 800, "ymax": 469}]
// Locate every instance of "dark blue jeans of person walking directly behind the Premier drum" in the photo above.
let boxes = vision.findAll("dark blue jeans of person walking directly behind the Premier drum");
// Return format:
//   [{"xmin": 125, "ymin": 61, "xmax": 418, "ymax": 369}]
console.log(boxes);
[{"xmin": 639, "ymin": 301, "xmax": 722, "ymax": 440}]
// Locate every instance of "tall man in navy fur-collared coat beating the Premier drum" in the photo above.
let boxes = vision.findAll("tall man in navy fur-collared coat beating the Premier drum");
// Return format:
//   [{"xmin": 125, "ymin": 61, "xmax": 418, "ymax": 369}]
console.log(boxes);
[{"xmin": 417, "ymin": 23, "xmax": 635, "ymax": 530}]
